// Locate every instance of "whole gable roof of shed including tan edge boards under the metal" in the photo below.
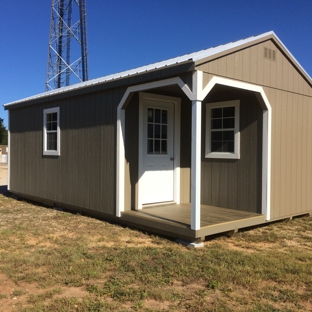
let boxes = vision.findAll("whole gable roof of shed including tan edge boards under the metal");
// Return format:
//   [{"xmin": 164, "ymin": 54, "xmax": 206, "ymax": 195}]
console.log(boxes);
[{"xmin": 4, "ymin": 31, "xmax": 312, "ymax": 109}]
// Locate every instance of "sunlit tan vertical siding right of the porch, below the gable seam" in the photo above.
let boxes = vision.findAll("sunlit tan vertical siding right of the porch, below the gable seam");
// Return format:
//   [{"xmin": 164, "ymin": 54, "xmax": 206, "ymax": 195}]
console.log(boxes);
[{"xmin": 266, "ymin": 90, "xmax": 312, "ymax": 219}]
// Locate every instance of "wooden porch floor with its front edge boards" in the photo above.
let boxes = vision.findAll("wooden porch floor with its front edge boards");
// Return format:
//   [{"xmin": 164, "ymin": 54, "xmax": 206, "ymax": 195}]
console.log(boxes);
[{"xmin": 121, "ymin": 204, "xmax": 266, "ymax": 240}]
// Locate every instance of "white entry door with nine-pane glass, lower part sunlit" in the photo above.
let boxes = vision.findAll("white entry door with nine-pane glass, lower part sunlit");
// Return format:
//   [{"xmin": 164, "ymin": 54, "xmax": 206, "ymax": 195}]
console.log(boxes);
[{"xmin": 139, "ymin": 99, "xmax": 174, "ymax": 205}]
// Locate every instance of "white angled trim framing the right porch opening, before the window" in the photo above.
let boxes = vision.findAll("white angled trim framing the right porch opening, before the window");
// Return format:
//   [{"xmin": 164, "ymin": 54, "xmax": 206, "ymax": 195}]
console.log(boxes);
[{"xmin": 200, "ymin": 76, "xmax": 272, "ymax": 220}]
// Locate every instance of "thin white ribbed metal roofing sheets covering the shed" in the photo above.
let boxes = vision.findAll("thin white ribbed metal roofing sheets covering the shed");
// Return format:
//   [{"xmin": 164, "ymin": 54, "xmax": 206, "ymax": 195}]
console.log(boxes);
[{"xmin": 4, "ymin": 31, "xmax": 311, "ymax": 108}]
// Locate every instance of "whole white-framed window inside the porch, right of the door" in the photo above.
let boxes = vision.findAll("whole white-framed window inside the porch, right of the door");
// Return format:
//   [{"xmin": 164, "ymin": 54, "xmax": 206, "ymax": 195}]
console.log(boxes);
[{"xmin": 206, "ymin": 100, "xmax": 240, "ymax": 159}]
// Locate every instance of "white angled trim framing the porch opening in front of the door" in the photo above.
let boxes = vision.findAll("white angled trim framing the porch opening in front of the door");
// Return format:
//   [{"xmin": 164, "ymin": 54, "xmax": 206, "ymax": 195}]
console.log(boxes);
[{"xmin": 116, "ymin": 77, "xmax": 193, "ymax": 217}]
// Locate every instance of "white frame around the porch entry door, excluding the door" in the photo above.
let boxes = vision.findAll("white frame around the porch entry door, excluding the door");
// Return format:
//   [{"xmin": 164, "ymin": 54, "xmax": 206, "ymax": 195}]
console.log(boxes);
[{"xmin": 136, "ymin": 92, "xmax": 181, "ymax": 209}]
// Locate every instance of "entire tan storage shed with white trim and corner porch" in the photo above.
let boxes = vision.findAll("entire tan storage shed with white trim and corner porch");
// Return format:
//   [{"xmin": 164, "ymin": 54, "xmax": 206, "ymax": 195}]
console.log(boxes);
[{"xmin": 4, "ymin": 32, "xmax": 312, "ymax": 240}]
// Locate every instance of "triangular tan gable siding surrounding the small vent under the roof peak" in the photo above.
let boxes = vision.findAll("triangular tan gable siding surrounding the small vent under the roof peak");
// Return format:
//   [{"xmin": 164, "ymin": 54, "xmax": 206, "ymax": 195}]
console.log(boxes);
[{"xmin": 196, "ymin": 40, "xmax": 312, "ymax": 96}]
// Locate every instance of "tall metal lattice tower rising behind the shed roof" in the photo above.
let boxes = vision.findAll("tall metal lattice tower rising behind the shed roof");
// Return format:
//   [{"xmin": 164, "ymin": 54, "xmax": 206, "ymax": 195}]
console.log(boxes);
[{"xmin": 46, "ymin": 0, "xmax": 89, "ymax": 91}]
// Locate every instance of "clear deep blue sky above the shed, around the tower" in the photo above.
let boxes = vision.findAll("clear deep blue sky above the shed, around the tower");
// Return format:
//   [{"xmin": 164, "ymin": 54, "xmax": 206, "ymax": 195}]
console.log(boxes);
[{"xmin": 0, "ymin": 0, "xmax": 312, "ymax": 126}]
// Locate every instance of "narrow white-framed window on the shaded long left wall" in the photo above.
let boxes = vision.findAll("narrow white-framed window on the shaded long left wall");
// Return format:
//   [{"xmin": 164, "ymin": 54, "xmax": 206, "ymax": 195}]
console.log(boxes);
[{"xmin": 43, "ymin": 107, "xmax": 60, "ymax": 156}]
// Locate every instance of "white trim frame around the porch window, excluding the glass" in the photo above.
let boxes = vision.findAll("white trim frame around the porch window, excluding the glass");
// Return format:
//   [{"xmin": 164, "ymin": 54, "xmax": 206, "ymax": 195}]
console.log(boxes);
[{"xmin": 205, "ymin": 100, "xmax": 240, "ymax": 159}]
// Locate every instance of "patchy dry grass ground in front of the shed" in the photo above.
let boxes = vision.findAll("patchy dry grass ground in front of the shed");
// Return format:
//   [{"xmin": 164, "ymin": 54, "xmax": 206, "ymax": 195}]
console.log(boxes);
[{"xmin": 0, "ymin": 195, "xmax": 312, "ymax": 311}]
